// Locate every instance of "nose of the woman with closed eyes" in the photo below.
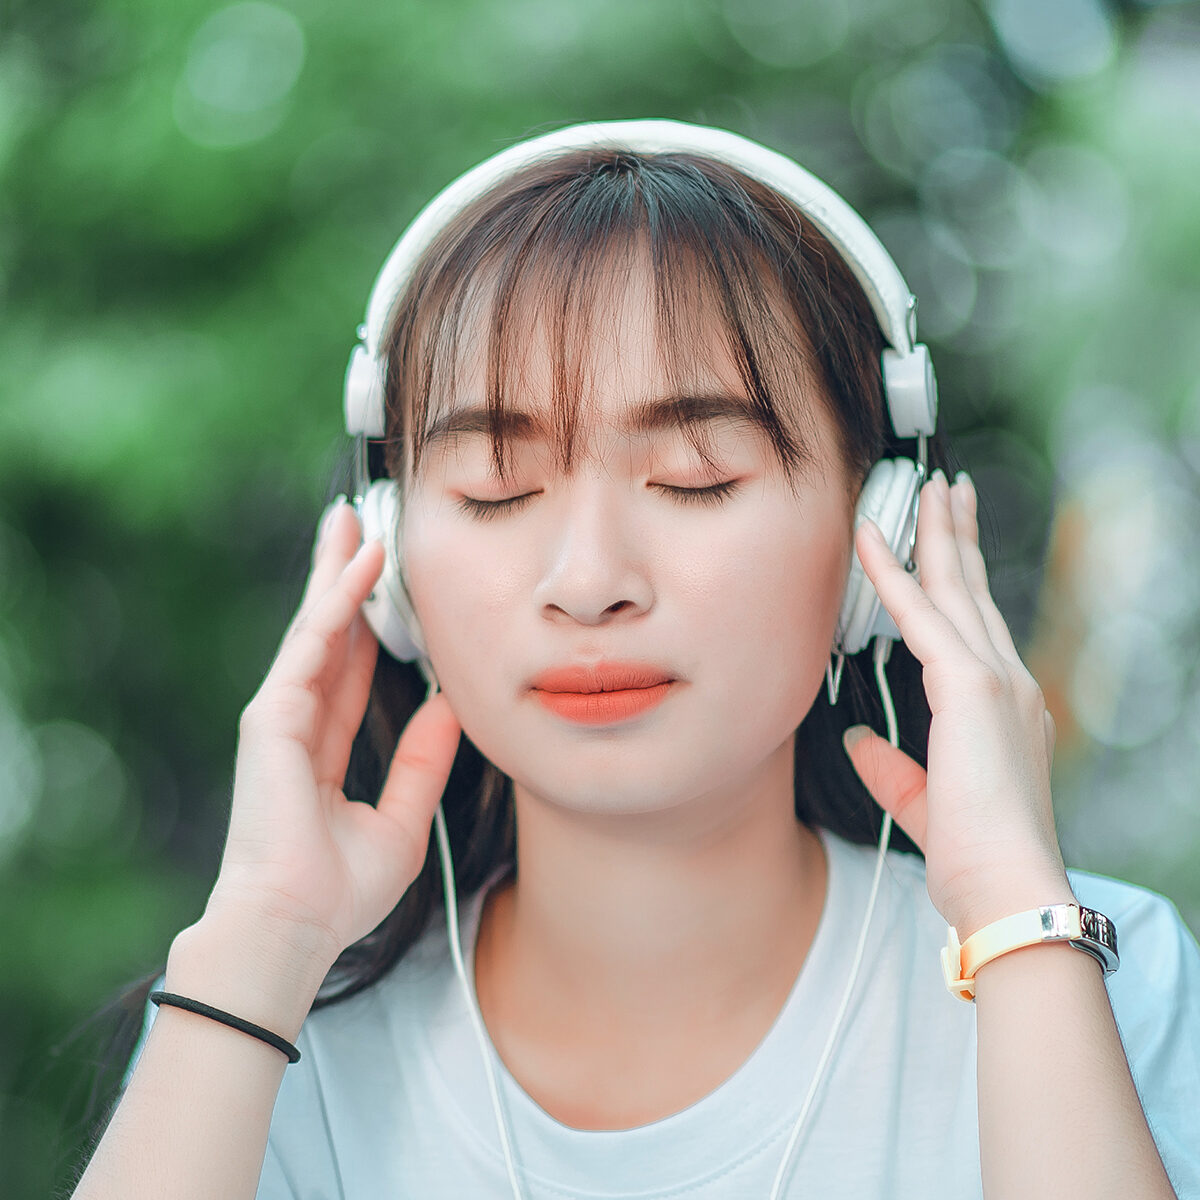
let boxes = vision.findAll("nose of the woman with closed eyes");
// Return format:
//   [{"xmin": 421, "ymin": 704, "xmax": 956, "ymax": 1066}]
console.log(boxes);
[{"xmin": 534, "ymin": 476, "xmax": 653, "ymax": 625}]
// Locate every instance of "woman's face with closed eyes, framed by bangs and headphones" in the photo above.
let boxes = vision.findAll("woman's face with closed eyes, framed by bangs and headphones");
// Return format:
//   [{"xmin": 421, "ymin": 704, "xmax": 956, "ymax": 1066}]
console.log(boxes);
[{"xmin": 403, "ymin": 252, "xmax": 853, "ymax": 812}]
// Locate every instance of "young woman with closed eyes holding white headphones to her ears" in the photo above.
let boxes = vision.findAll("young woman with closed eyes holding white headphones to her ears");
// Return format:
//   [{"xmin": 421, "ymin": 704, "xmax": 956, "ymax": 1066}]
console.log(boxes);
[{"xmin": 76, "ymin": 121, "xmax": 1200, "ymax": 1200}]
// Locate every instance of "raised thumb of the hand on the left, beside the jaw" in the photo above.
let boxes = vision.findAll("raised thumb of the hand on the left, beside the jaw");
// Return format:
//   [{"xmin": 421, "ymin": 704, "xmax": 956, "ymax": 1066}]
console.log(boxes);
[{"xmin": 376, "ymin": 691, "xmax": 462, "ymax": 876}]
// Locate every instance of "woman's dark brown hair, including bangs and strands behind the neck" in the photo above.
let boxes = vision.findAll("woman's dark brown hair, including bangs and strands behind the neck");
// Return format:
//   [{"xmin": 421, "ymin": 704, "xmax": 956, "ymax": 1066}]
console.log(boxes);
[{"xmin": 75, "ymin": 140, "xmax": 954, "ymax": 1171}]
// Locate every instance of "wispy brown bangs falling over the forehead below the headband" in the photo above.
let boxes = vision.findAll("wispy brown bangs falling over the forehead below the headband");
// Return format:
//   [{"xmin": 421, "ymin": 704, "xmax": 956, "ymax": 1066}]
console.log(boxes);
[{"xmin": 384, "ymin": 150, "xmax": 865, "ymax": 496}]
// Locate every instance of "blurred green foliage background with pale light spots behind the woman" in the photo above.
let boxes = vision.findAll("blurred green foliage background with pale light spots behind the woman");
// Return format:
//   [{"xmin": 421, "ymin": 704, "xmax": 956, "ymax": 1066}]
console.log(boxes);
[{"xmin": 0, "ymin": 0, "xmax": 1200, "ymax": 1200}]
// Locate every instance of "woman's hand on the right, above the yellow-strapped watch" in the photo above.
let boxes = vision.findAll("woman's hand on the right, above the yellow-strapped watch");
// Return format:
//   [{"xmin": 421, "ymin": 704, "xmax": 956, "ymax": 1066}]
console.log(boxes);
[{"xmin": 846, "ymin": 470, "xmax": 1074, "ymax": 938}]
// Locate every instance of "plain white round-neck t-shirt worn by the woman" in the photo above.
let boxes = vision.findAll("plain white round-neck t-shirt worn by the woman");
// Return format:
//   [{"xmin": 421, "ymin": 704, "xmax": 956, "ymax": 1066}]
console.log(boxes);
[{"xmin": 121, "ymin": 830, "xmax": 1200, "ymax": 1200}]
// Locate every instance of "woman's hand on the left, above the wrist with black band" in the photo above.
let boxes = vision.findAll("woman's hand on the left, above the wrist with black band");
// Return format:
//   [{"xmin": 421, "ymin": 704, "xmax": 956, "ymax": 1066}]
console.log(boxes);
[{"xmin": 206, "ymin": 502, "xmax": 461, "ymax": 964}]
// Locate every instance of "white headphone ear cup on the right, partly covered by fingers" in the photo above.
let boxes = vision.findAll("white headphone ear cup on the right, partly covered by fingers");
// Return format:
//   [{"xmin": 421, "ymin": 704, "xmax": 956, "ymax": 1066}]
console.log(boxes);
[{"xmin": 834, "ymin": 458, "xmax": 920, "ymax": 654}]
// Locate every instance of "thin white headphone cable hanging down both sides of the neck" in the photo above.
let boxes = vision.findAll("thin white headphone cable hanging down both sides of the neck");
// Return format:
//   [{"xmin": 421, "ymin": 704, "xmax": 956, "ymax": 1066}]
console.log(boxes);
[{"xmin": 426, "ymin": 637, "xmax": 899, "ymax": 1200}]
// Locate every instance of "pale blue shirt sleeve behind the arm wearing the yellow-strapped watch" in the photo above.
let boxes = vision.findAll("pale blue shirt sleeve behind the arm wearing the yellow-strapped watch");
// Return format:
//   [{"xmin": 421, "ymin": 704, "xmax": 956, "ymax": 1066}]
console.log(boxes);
[{"xmin": 1075, "ymin": 876, "xmax": 1200, "ymax": 1200}]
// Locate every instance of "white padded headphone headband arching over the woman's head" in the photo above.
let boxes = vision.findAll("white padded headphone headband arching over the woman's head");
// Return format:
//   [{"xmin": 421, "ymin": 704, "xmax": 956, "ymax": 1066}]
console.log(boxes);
[{"xmin": 346, "ymin": 119, "xmax": 937, "ymax": 437}]
